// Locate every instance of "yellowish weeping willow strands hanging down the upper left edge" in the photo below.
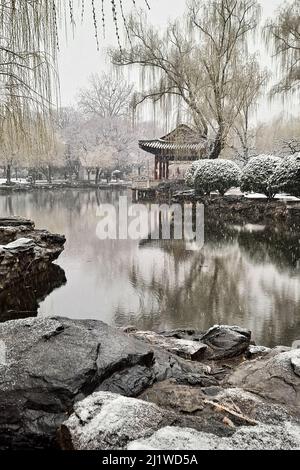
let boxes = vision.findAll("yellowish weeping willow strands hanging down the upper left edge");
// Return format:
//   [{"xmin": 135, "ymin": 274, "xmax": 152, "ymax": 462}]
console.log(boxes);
[{"xmin": 0, "ymin": 0, "xmax": 149, "ymax": 180}]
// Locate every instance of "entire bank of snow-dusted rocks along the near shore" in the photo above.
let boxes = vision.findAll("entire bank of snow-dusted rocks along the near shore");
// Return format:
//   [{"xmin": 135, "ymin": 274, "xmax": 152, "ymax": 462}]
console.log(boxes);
[{"xmin": 0, "ymin": 318, "xmax": 300, "ymax": 450}]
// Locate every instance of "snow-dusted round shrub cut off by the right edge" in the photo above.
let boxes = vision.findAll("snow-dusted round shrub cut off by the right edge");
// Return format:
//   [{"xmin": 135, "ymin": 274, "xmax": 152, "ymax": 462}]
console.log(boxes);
[{"xmin": 272, "ymin": 153, "xmax": 300, "ymax": 196}]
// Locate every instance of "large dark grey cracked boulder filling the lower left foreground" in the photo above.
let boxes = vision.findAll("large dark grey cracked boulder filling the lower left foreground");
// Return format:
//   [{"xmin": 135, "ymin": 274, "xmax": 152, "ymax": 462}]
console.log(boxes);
[{"xmin": 0, "ymin": 318, "xmax": 217, "ymax": 448}]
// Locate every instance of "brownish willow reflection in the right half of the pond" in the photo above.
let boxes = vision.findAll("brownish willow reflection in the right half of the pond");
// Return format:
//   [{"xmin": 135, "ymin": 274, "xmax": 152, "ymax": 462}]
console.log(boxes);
[{"xmin": 122, "ymin": 221, "xmax": 300, "ymax": 345}]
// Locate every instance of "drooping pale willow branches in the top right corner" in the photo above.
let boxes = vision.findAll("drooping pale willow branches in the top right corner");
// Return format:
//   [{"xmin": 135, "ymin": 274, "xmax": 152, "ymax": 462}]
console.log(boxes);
[{"xmin": 264, "ymin": 0, "xmax": 300, "ymax": 95}]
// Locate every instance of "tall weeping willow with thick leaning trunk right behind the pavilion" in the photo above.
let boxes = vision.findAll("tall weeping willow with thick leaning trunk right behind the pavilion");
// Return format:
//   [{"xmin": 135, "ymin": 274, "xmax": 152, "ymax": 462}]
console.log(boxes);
[{"xmin": 111, "ymin": 0, "xmax": 260, "ymax": 158}]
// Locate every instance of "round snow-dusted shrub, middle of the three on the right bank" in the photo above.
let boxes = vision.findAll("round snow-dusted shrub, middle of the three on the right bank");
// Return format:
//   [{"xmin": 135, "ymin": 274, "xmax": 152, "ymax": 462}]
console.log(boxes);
[{"xmin": 241, "ymin": 155, "xmax": 281, "ymax": 198}]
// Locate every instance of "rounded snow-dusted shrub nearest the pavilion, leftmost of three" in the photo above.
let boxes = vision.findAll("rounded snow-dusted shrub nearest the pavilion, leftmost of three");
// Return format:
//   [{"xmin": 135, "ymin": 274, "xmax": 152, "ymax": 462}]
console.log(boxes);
[{"xmin": 195, "ymin": 159, "xmax": 241, "ymax": 196}]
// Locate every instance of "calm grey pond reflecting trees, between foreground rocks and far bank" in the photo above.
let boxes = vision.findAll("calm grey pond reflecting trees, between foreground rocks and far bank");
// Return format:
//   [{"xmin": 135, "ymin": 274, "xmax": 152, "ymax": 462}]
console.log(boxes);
[{"xmin": 0, "ymin": 190, "xmax": 300, "ymax": 346}]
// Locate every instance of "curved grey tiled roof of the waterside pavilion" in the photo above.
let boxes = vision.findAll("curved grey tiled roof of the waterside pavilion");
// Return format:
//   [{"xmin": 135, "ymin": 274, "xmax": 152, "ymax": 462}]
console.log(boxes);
[{"xmin": 139, "ymin": 124, "xmax": 207, "ymax": 160}]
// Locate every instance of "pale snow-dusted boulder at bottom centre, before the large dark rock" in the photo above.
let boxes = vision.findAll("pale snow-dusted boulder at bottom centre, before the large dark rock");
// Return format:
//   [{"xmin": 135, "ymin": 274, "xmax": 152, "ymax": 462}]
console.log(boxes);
[{"xmin": 59, "ymin": 392, "xmax": 174, "ymax": 450}]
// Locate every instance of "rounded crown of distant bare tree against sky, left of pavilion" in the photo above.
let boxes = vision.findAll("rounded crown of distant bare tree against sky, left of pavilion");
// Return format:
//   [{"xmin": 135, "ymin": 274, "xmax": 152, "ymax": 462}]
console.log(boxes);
[{"xmin": 78, "ymin": 73, "xmax": 133, "ymax": 119}]
